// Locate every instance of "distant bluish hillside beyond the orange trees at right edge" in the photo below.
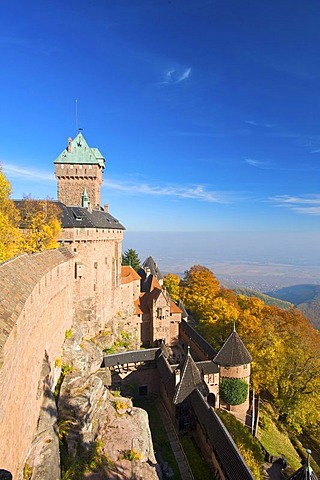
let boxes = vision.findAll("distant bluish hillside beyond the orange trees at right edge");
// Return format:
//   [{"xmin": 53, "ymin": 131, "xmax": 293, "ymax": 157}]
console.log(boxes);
[{"xmin": 266, "ymin": 284, "xmax": 320, "ymax": 330}]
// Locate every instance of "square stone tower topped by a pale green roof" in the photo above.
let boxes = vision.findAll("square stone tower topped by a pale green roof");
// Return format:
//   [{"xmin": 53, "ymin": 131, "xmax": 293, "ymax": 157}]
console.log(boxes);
[{"xmin": 54, "ymin": 132, "xmax": 105, "ymax": 209}]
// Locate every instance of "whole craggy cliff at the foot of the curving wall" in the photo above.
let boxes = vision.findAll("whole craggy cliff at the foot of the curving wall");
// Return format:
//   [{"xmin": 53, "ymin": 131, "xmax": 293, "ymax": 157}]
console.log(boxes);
[{"xmin": 24, "ymin": 327, "xmax": 161, "ymax": 480}]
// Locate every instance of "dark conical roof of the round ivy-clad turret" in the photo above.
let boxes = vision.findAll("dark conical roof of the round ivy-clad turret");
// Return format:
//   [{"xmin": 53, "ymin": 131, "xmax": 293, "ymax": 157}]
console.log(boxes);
[{"xmin": 213, "ymin": 329, "xmax": 252, "ymax": 367}]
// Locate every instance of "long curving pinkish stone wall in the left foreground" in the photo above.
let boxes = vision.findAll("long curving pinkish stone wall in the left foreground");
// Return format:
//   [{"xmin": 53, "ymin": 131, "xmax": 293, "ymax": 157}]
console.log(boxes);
[{"xmin": 0, "ymin": 248, "xmax": 74, "ymax": 479}]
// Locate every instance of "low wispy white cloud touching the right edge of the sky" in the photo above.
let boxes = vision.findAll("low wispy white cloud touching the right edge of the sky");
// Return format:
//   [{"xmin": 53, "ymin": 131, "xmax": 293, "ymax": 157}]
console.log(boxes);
[{"xmin": 270, "ymin": 193, "xmax": 320, "ymax": 215}]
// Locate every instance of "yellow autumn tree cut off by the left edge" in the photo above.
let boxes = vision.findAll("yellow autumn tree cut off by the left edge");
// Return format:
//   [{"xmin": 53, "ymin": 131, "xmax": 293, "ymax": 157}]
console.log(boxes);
[{"xmin": 0, "ymin": 167, "xmax": 22, "ymax": 262}]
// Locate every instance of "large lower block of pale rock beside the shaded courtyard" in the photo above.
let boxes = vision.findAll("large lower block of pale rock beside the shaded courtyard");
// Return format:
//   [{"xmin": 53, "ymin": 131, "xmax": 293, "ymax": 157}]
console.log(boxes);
[{"xmin": 59, "ymin": 374, "xmax": 161, "ymax": 480}]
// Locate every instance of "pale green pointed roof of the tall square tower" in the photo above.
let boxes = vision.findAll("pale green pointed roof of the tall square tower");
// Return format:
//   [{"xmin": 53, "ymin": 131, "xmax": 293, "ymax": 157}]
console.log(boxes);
[{"xmin": 54, "ymin": 132, "xmax": 105, "ymax": 168}]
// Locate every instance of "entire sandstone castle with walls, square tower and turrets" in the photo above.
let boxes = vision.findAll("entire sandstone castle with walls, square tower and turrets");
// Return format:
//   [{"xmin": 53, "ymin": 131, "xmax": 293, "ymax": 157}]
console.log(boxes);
[{"xmin": 0, "ymin": 132, "xmax": 252, "ymax": 480}]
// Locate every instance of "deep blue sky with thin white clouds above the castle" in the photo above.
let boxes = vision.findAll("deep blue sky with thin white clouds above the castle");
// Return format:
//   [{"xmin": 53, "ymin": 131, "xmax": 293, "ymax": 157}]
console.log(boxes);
[{"xmin": 0, "ymin": 0, "xmax": 320, "ymax": 238}]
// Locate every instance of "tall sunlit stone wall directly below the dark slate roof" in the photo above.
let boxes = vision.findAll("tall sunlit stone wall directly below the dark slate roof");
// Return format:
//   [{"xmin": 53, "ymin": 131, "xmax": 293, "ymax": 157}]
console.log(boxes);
[{"xmin": 64, "ymin": 228, "xmax": 123, "ymax": 337}]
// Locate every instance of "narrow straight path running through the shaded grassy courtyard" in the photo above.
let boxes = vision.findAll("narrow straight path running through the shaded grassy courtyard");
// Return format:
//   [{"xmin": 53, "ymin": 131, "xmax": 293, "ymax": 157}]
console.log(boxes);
[{"xmin": 155, "ymin": 398, "xmax": 194, "ymax": 480}]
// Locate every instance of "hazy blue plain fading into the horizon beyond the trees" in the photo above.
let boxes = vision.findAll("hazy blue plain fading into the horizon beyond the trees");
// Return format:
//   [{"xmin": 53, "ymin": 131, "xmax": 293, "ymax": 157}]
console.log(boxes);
[{"xmin": 123, "ymin": 231, "xmax": 320, "ymax": 291}]
